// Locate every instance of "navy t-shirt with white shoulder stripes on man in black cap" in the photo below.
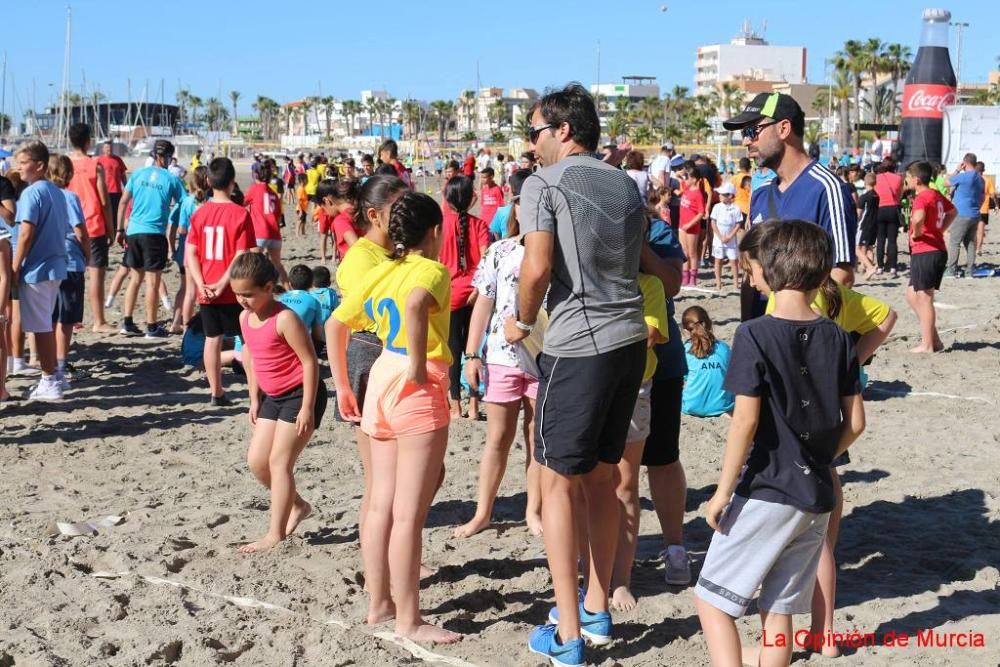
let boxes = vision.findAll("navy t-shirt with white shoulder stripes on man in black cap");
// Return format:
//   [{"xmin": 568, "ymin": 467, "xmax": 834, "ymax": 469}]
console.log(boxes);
[{"xmin": 750, "ymin": 160, "xmax": 860, "ymax": 264}]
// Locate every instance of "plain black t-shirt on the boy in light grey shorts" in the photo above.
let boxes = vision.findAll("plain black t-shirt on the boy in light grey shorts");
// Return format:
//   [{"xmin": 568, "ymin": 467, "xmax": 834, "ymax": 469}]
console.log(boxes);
[{"xmin": 724, "ymin": 315, "xmax": 861, "ymax": 513}]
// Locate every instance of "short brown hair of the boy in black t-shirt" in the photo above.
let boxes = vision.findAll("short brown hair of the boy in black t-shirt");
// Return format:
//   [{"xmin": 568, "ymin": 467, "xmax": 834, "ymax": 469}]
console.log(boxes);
[{"xmin": 757, "ymin": 220, "xmax": 833, "ymax": 292}]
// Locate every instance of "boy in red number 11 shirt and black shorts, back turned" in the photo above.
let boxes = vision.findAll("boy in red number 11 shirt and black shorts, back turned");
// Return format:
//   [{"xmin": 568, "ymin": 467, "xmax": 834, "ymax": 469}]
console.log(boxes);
[{"xmin": 184, "ymin": 157, "xmax": 258, "ymax": 407}]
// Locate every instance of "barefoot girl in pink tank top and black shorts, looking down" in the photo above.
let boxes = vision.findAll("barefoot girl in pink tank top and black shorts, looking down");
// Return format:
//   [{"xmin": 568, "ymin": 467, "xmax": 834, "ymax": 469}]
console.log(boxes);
[{"xmin": 229, "ymin": 252, "xmax": 327, "ymax": 553}]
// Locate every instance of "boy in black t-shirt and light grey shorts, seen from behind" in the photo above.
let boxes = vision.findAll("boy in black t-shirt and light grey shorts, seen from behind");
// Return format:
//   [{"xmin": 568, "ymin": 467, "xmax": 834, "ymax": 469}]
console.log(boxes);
[{"xmin": 695, "ymin": 220, "xmax": 865, "ymax": 665}]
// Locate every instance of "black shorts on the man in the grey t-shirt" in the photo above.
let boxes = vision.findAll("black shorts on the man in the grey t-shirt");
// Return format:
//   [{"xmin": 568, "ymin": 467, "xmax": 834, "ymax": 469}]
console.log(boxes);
[{"xmin": 535, "ymin": 341, "xmax": 646, "ymax": 475}]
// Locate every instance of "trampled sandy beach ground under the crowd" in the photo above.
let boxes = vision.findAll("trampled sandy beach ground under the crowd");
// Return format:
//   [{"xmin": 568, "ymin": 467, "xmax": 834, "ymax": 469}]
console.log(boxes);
[{"xmin": 0, "ymin": 163, "xmax": 1000, "ymax": 667}]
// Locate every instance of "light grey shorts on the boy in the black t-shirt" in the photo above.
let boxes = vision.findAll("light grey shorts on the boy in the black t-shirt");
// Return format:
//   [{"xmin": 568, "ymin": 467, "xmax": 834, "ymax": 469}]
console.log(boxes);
[{"xmin": 694, "ymin": 496, "xmax": 830, "ymax": 617}]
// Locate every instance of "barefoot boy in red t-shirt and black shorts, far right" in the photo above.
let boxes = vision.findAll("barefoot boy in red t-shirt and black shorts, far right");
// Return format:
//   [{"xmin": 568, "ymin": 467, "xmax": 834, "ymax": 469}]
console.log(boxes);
[{"xmin": 906, "ymin": 162, "xmax": 956, "ymax": 353}]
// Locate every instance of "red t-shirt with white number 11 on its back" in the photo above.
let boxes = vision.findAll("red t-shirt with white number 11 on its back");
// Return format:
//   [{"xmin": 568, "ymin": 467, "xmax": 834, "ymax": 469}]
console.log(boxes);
[{"xmin": 187, "ymin": 201, "xmax": 258, "ymax": 304}]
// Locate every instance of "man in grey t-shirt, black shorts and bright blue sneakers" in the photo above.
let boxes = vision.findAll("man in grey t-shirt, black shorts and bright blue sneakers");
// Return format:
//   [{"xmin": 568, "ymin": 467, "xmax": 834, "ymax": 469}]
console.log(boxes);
[{"xmin": 505, "ymin": 84, "xmax": 646, "ymax": 664}]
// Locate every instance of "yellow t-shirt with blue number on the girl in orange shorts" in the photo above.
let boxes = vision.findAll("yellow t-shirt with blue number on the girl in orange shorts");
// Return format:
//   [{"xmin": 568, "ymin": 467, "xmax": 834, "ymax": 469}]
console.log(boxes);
[{"xmin": 333, "ymin": 254, "xmax": 452, "ymax": 364}]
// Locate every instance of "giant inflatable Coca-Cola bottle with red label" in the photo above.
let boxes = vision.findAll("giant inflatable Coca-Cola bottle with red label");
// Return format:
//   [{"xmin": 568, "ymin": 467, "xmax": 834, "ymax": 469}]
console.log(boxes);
[{"xmin": 897, "ymin": 9, "xmax": 958, "ymax": 167}]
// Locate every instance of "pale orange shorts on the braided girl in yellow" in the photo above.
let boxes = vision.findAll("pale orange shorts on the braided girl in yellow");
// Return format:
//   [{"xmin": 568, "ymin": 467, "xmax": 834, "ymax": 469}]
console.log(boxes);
[{"xmin": 361, "ymin": 350, "xmax": 451, "ymax": 440}]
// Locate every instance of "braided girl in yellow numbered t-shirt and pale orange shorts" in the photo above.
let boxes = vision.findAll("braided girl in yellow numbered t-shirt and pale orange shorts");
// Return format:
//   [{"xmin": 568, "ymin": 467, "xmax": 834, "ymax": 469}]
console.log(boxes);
[{"xmin": 328, "ymin": 192, "xmax": 461, "ymax": 643}]
